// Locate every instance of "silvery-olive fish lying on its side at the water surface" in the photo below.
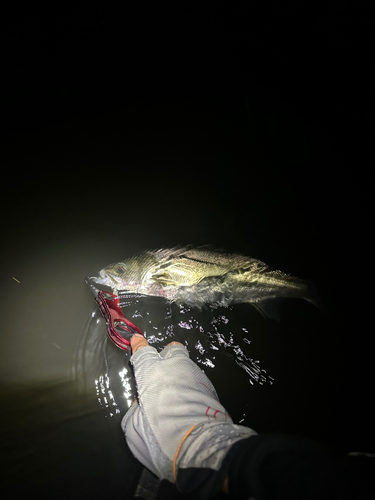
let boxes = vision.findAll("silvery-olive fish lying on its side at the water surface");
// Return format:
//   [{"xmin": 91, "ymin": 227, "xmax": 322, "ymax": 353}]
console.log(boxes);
[{"xmin": 87, "ymin": 245, "xmax": 319, "ymax": 320}]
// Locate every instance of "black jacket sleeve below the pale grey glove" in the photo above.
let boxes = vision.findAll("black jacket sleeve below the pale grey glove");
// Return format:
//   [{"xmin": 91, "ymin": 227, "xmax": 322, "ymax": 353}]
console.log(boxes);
[{"xmin": 177, "ymin": 433, "xmax": 375, "ymax": 500}]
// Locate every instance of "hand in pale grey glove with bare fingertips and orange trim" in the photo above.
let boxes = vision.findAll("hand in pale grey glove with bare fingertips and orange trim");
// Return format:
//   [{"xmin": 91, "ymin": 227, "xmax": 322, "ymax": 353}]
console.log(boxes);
[{"xmin": 121, "ymin": 334, "xmax": 256, "ymax": 492}]
